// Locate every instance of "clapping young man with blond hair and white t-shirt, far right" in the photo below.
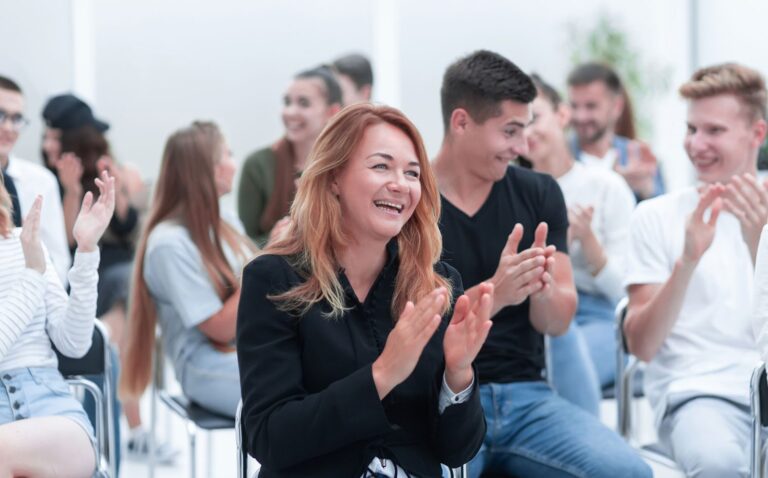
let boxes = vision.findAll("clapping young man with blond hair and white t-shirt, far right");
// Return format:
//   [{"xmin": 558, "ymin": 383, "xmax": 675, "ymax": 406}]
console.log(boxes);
[{"xmin": 624, "ymin": 64, "xmax": 768, "ymax": 477}]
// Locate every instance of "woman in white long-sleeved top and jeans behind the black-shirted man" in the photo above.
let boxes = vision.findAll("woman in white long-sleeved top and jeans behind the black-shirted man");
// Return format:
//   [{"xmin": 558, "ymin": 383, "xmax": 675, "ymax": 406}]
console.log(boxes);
[{"xmin": 526, "ymin": 75, "xmax": 635, "ymax": 416}]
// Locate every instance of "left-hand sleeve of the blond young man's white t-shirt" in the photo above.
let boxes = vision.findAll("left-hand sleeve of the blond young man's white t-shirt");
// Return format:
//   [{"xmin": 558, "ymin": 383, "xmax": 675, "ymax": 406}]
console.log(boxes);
[{"xmin": 624, "ymin": 201, "xmax": 682, "ymax": 287}]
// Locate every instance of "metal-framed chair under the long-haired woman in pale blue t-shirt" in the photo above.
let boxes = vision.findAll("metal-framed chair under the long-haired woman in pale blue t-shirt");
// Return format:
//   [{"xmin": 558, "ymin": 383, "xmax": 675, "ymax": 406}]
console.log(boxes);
[{"xmin": 149, "ymin": 336, "xmax": 235, "ymax": 478}]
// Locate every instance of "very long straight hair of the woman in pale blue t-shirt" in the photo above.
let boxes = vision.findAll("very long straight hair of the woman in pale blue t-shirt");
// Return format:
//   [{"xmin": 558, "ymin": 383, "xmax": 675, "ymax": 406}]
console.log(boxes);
[{"xmin": 120, "ymin": 121, "xmax": 256, "ymax": 396}]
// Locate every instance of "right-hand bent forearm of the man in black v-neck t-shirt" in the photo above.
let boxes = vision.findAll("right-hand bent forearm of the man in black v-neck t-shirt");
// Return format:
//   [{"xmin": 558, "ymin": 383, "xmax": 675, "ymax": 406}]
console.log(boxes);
[{"xmin": 530, "ymin": 283, "xmax": 578, "ymax": 336}]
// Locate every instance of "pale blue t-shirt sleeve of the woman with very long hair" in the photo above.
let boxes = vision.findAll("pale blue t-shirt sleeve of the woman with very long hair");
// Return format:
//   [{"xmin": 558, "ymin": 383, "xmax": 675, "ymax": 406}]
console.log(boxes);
[{"xmin": 144, "ymin": 240, "xmax": 223, "ymax": 328}]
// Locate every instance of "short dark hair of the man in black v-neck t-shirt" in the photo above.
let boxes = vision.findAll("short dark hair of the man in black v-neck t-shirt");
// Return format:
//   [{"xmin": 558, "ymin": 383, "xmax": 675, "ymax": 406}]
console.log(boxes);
[{"xmin": 440, "ymin": 50, "xmax": 536, "ymax": 131}]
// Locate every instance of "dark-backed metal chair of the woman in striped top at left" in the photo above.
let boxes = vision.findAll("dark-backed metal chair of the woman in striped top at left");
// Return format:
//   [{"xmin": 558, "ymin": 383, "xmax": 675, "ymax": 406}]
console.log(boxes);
[{"xmin": 53, "ymin": 320, "xmax": 117, "ymax": 478}]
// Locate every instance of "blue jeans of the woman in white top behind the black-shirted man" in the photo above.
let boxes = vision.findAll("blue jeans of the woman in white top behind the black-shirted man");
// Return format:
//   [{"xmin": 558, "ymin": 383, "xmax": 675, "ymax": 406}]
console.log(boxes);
[{"xmin": 550, "ymin": 292, "xmax": 616, "ymax": 416}]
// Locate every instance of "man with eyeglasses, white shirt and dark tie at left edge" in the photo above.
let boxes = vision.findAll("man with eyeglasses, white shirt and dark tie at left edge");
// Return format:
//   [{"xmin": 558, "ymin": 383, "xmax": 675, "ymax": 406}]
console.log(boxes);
[{"xmin": 0, "ymin": 76, "xmax": 71, "ymax": 287}]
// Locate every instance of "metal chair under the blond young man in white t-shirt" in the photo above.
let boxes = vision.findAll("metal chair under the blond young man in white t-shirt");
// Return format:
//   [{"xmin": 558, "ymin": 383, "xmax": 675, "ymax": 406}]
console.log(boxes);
[{"xmin": 615, "ymin": 297, "xmax": 682, "ymax": 473}]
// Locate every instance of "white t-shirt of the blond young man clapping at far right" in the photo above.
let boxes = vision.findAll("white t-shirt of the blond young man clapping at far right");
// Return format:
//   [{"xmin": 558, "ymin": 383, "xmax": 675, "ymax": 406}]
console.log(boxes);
[{"xmin": 624, "ymin": 187, "xmax": 759, "ymax": 426}]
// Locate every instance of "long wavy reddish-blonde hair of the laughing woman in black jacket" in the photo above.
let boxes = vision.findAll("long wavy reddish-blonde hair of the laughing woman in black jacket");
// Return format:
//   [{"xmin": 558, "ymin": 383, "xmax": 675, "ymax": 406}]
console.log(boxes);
[{"xmin": 264, "ymin": 103, "xmax": 451, "ymax": 320}]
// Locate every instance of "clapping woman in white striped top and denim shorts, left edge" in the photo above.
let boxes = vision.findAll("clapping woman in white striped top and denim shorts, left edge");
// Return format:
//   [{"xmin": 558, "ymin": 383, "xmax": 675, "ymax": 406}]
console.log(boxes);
[{"xmin": 0, "ymin": 173, "xmax": 115, "ymax": 478}]
